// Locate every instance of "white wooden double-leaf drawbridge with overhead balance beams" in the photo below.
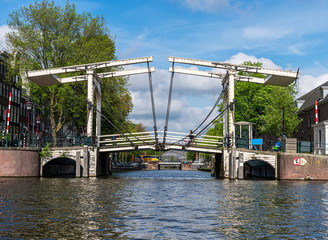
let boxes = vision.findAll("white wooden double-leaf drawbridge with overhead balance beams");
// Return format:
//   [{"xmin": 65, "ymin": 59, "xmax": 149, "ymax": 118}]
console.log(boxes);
[{"xmin": 26, "ymin": 54, "xmax": 299, "ymax": 178}]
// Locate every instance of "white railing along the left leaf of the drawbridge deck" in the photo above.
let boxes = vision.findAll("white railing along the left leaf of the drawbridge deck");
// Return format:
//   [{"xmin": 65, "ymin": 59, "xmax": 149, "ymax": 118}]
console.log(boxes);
[{"xmin": 98, "ymin": 132, "xmax": 156, "ymax": 147}]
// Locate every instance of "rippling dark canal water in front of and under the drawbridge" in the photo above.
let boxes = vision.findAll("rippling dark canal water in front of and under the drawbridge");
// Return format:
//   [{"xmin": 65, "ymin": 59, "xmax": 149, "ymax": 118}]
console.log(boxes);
[{"xmin": 0, "ymin": 170, "xmax": 328, "ymax": 239}]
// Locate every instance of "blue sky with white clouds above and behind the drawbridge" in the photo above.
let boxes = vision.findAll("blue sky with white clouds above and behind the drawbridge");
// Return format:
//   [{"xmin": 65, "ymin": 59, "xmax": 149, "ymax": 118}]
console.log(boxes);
[{"xmin": 0, "ymin": 0, "xmax": 328, "ymax": 131}]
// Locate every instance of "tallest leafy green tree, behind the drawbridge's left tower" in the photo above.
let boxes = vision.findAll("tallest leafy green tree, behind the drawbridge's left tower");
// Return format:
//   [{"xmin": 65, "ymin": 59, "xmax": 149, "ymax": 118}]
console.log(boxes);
[{"xmin": 6, "ymin": 0, "xmax": 132, "ymax": 141}]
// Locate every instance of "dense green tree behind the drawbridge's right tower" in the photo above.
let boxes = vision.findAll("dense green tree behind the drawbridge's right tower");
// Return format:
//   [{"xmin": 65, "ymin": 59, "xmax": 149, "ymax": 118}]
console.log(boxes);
[{"xmin": 208, "ymin": 62, "xmax": 300, "ymax": 137}]
